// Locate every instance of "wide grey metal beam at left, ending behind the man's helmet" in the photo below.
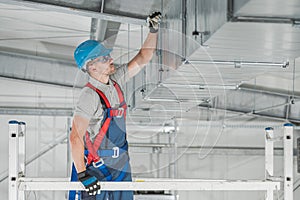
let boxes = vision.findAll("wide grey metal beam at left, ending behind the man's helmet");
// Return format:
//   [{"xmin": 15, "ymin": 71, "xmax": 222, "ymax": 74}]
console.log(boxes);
[{"xmin": 0, "ymin": 52, "xmax": 84, "ymax": 88}]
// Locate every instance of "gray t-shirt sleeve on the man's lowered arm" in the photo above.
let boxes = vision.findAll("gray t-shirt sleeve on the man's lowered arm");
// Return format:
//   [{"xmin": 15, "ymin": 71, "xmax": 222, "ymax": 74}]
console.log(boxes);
[{"xmin": 74, "ymin": 87, "xmax": 100, "ymax": 120}]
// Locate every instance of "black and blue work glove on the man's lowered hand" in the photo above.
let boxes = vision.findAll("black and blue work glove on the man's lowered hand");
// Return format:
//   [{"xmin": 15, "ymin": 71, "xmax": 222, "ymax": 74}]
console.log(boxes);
[{"xmin": 77, "ymin": 171, "xmax": 101, "ymax": 195}]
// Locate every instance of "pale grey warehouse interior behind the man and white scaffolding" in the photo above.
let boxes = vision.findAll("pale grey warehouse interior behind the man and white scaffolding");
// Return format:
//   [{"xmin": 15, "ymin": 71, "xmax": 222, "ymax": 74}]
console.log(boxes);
[{"xmin": 0, "ymin": 0, "xmax": 300, "ymax": 199}]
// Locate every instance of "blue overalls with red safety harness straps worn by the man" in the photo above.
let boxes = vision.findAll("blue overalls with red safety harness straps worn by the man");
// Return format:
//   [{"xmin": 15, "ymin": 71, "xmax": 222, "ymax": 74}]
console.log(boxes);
[{"xmin": 69, "ymin": 81, "xmax": 133, "ymax": 200}]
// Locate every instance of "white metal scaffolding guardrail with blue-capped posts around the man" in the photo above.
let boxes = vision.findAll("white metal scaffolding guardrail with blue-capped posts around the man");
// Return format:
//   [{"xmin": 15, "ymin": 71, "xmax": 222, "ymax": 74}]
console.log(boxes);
[{"xmin": 8, "ymin": 120, "xmax": 293, "ymax": 200}]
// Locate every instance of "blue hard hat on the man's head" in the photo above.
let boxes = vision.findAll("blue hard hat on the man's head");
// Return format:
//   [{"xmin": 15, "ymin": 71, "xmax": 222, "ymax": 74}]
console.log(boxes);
[{"xmin": 74, "ymin": 40, "xmax": 112, "ymax": 69}]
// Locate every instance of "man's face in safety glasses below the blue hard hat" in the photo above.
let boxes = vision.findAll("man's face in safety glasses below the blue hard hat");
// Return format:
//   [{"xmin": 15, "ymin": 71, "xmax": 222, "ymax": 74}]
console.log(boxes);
[{"xmin": 87, "ymin": 55, "xmax": 116, "ymax": 76}]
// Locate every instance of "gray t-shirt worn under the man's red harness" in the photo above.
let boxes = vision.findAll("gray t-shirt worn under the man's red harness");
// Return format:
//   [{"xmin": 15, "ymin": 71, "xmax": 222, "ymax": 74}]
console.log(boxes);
[{"xmin": 74, "ymin": 64, "xmax": 129, "ymax": 141}]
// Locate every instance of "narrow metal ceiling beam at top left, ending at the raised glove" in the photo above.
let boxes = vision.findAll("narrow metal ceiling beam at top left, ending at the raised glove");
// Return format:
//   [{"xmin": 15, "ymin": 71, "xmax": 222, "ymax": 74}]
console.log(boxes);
[{"xmin": 0, "ymin": 0, "xmax": 146, "ymax": 25}]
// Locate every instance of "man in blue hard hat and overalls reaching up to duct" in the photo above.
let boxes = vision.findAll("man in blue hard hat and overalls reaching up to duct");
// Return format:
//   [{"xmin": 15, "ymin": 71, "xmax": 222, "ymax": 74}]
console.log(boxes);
[{"xmin": 70, "ymin": 12, "xmax": 161, "ymax": 200}]
